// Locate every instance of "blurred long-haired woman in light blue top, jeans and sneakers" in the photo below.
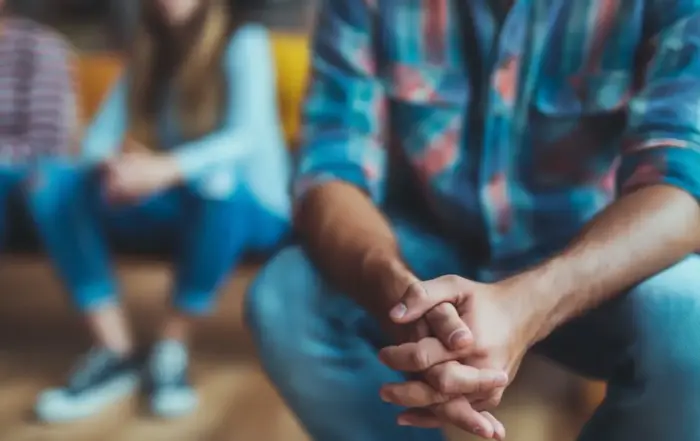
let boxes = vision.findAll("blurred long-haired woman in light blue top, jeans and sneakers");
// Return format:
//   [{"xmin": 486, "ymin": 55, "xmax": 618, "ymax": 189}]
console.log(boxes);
[{"xmin": 30, "ymin": 0, "xmax": 290, "ymax": 421}]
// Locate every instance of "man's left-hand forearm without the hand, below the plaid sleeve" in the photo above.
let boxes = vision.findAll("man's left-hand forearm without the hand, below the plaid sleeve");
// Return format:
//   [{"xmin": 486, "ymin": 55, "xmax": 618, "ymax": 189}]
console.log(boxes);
[{"xmin": 296, "ymin": 181, "xmax": 413, "ymax": 314}]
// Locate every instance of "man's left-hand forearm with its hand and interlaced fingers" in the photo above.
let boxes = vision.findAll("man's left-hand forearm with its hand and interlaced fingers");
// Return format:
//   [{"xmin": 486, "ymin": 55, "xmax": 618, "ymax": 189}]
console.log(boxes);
[{"xmin": 296, "ymin": 182, "xmax": 508, "ymax": 432}]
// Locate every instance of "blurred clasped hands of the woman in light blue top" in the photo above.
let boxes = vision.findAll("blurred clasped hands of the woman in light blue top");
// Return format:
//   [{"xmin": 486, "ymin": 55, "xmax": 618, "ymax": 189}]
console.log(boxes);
[{"xmin": 104, "ymin": 151, "xmax": 182, "ymax": 203}]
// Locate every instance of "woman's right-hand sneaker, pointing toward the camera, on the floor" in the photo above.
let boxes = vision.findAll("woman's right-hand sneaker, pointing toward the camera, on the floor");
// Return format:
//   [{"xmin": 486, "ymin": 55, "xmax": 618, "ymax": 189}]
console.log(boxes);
[{"xmin": 148, "ymin": 340, "xmax": 199, "ymax": 418}]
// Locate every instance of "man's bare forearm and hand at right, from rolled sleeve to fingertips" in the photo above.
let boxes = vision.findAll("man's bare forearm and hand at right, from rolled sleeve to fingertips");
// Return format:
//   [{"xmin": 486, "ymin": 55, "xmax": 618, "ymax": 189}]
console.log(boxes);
[{"xmin": 380, "ymin": 186, "xmax": 700, "ymax": 439}]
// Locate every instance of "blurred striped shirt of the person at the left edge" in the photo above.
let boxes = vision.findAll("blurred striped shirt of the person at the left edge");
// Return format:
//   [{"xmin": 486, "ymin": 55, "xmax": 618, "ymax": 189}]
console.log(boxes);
[{"xmin": 0, "ymin": 18, "xmax": 78, "ymax": 164}]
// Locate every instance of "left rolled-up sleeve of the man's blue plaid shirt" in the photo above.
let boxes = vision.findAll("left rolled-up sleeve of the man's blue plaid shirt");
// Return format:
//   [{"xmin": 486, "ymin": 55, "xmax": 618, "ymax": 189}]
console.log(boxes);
[{"xmin": 294, "ymin": 0, "xmax": 387, "ymax": 202}]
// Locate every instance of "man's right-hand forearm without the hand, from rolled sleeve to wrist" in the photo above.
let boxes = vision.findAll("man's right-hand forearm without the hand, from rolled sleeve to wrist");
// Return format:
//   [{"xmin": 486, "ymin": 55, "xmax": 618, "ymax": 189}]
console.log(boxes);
[{"xmin": 504, "ymin": 186, "xmax": 700, "ymax": 343}]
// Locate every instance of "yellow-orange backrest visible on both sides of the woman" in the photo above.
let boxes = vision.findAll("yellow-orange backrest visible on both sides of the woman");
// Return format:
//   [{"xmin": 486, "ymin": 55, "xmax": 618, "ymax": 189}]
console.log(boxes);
[{"xmin": 78, "ymin": 33, "xmax": 309, "ymax": 146}]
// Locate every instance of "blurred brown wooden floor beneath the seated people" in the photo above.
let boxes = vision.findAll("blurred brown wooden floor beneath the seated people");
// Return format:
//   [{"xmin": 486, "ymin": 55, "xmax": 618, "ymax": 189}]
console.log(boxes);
[{"xmin": 0, "ymin": 259, "xmax": 592, "ymax": 441}]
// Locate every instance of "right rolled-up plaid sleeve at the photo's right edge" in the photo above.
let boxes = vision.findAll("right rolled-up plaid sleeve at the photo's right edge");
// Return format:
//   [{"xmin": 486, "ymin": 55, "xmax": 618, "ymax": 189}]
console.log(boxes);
[{"xmin": 617, "ymin": 0, "xmax": 700, "ymax": 201}]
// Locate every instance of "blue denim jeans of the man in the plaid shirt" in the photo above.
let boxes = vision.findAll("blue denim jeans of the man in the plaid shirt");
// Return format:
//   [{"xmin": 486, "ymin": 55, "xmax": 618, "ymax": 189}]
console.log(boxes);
[{"xmin": 246, "ymin": 214, "xmax": 700, "ymax": 441}]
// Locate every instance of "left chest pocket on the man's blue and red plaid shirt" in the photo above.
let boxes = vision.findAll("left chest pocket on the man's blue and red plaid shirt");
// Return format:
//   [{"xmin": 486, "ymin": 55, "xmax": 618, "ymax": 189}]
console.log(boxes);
[{"xmin": 384, "ymin": 63, "xmax": 471, "ymax": 178}]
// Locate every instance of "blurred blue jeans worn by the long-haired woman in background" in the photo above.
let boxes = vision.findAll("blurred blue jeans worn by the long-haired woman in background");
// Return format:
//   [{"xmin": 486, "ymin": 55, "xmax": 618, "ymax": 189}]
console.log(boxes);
[{"xmin": 27, "ymin": 164, "xmax": 288, "ymax": 315}]
